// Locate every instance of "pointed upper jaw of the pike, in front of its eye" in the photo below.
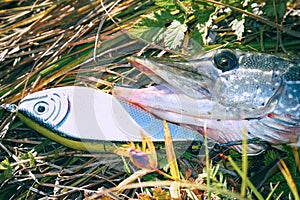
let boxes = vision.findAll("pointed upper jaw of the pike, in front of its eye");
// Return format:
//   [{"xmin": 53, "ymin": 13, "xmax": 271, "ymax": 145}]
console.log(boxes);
[{"xmin": 128, "ymin": 57, "xmax": 213, "ymax": 99}]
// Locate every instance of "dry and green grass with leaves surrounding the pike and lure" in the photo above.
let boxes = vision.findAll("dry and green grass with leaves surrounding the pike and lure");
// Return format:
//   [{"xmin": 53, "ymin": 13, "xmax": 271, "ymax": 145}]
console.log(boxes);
[{"xmin": 0, "ymin": 0, "xmax": 300, "ymax": 199}]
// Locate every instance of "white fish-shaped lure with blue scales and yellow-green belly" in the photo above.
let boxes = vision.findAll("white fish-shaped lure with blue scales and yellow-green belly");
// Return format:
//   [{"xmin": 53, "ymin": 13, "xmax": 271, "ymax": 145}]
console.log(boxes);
[{"xmin": 17, "ymin": 86, "xmax": 202, "ymax": 152}]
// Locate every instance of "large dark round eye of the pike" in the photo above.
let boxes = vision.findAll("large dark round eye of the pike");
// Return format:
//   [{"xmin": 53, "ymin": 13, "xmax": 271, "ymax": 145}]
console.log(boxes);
[{"xmin": 214, "ymin": 50, "xmax": 238, "ymax": 72}]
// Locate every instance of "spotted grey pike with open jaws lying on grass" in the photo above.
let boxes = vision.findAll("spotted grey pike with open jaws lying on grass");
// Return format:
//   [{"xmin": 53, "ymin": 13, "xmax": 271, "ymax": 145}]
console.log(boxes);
[{"xmin": 113, "ymin": 49, "xmax": 300, "ymax": 153}]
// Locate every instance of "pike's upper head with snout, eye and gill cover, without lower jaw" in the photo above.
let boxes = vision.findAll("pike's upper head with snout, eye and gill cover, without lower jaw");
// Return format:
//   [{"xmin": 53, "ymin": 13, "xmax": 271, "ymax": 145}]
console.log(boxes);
[{"xmin": 130, "ymin": 49, "xmax": 288, "ymax": 118}]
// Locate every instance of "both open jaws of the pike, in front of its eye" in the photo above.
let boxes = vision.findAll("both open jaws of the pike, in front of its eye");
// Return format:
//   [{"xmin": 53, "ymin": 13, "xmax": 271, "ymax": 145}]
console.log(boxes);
[{"xmin": 112, "ymin": 55, "xmax": 246, "ymax": 121}]
